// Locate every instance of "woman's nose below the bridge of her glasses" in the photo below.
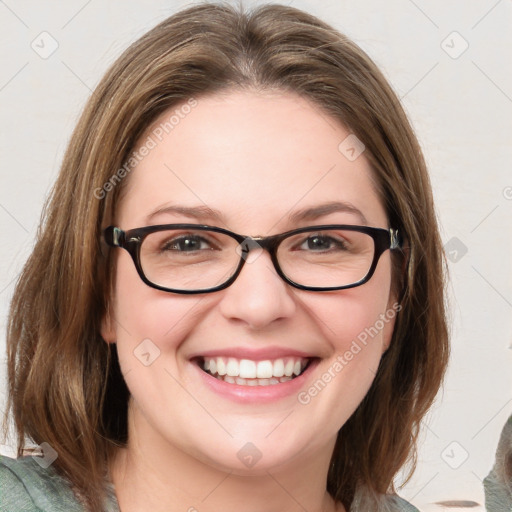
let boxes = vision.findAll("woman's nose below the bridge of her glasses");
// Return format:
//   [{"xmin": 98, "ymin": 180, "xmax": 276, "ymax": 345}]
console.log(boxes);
[{"xmin": 219, "ymin": 251, "xmax": 296, "ymax": 329}]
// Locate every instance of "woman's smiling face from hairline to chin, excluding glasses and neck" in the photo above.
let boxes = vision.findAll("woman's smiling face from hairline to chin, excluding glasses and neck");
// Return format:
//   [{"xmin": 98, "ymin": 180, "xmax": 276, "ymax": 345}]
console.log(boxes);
[{"xmin": 102, "ymin": 92, "xmax": 396, "ymax": 472}]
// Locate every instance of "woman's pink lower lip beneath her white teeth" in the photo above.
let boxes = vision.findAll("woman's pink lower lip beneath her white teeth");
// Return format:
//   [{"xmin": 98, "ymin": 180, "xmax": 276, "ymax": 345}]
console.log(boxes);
[{"xmin": 192, "ymin": 359, "xmax": 318, "ymax": 403}]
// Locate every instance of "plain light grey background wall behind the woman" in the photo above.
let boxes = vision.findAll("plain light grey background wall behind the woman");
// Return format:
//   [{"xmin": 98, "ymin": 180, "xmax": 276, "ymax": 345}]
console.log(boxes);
[{"xmin": 0, "ymin": 0, "xmax": 512, "ymax": 511}]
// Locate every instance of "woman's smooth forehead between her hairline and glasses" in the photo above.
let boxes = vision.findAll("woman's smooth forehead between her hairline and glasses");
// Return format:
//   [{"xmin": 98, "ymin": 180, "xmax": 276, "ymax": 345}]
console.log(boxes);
[{"xmin": 116, "ymin": 91, "xmax": 386, "ymax": 234}]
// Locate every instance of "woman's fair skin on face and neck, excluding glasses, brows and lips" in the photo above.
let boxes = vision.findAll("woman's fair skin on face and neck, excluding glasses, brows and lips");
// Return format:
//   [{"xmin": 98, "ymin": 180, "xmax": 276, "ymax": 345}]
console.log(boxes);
[{"xmin": 102, "ymin": 91, "xmax": 395, "ymax": 512}]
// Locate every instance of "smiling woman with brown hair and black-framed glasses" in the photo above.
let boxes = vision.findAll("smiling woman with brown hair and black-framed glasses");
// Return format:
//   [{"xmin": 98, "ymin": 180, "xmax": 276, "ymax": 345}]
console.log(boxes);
[{"xmin": 2, "ymin": 5, "xmax": 448, "ymax": 512}]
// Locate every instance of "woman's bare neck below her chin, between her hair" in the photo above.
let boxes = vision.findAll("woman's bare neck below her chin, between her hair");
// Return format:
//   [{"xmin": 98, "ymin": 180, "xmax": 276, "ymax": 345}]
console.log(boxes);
[{"xmin": 111, "ymin": 400, "xmax": 345, "ymax": 512}]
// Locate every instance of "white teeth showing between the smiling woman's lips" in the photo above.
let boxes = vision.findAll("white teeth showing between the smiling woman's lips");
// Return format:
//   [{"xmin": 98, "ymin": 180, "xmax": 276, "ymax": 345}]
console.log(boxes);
[{"xmin": 197, "ymin": 357, "xmax": 312, "ymax": 386}]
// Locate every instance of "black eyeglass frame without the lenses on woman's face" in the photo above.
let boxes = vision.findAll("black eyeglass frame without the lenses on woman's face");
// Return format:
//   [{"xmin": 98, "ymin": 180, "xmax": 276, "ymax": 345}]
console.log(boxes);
[{"xmin": 103, "ymin": 224, "xmax": 403, "ymax": 295}]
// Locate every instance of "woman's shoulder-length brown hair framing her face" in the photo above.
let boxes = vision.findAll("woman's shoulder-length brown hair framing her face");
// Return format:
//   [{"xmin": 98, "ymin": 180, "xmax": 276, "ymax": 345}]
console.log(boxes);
[{"xmin": 6, "ymin": 4, "xmax": 449, "ymax": 511}]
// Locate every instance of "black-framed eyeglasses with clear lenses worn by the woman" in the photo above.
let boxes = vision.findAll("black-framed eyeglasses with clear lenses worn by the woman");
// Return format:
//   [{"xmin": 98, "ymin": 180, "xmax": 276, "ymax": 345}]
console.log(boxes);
[{"xmin": 104, "ymin": 224, "xmax": 402, "ymax": 294}]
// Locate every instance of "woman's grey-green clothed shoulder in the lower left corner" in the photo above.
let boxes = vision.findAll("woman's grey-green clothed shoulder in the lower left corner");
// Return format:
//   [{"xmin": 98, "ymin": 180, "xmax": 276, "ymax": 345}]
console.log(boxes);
[{"xmin": 0, "ymin": 456, "xmax": 83, "ymax": 512}]
